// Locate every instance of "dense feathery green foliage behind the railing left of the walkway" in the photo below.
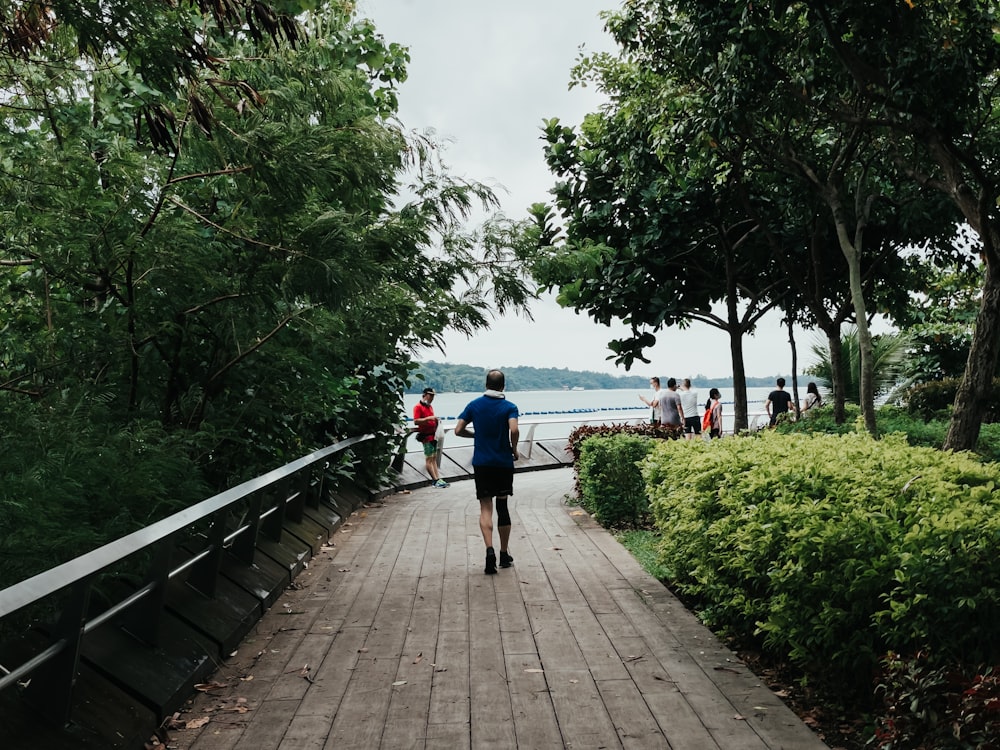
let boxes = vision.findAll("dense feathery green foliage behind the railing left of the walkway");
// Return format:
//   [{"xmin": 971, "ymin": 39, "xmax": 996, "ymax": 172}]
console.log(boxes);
[{"xmin": 0, "ymin": 0, "xmax": 532, "ymax": 592}]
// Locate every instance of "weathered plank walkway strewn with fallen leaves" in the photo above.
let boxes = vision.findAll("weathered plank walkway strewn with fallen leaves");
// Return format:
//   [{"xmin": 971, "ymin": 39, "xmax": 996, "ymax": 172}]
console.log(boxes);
[{"xmin": 169, "ymin": 468, "xmax": 826, "ymax": 750}]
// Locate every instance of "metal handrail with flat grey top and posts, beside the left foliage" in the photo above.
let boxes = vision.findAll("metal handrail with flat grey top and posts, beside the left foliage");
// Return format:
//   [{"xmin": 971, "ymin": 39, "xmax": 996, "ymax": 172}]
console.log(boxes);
[{"xmin": 0, "ymin": 434, "xmax": 375, "ymax": 721}]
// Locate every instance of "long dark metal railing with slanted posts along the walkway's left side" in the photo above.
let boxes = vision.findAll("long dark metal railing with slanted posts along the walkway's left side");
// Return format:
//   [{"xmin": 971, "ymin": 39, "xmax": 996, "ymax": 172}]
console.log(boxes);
[{"xmin": 0, "ymin": 435, "xmax": 374, "ymax": 722}]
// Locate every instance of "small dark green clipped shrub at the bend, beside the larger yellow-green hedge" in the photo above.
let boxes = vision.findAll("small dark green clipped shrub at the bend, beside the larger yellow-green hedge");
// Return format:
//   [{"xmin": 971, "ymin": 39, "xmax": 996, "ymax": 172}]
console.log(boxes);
[{"xmin": 577, "ymin": 435, "xmax": 657, "ymax": 527}]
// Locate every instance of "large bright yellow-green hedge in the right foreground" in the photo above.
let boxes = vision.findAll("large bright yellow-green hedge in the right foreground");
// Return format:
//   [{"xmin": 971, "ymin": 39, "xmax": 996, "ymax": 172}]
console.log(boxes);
[{"xmin": 643, "ymin": 431, "xmax": 1000, "ymax": 679}]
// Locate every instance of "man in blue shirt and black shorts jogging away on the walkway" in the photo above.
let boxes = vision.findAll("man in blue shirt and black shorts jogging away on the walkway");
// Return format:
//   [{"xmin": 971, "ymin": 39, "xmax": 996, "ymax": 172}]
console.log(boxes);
[{"xmin": 455, "ymin": 370, "xmax": 520, "ymax": 575}]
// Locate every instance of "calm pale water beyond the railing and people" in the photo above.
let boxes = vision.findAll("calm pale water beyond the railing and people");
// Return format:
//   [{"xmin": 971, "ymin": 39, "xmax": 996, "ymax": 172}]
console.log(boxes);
[{"xmin": 404, "ymin": 387, "xmax": 773, "ymax": 450}]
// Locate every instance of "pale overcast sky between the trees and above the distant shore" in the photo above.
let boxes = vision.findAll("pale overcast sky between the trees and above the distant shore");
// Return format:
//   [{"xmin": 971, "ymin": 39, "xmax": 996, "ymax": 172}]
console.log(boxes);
[{"xmin": 358, "ymin": 0, "xmax": 813, "ymax": 378}]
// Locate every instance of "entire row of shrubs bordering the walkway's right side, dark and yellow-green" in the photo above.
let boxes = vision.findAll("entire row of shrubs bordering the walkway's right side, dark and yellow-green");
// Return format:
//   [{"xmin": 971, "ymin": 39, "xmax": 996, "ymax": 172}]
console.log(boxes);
[{"xmin": 576, "ymin": 431, "xmax": 1000, "ymax": 750}]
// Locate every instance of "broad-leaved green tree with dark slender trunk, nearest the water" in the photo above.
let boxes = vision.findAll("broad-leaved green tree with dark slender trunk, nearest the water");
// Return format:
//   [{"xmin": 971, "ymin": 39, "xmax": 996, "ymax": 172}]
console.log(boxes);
[{"xmin": 533, "ymin": 55, "xmax": 785, "ymax": 427}]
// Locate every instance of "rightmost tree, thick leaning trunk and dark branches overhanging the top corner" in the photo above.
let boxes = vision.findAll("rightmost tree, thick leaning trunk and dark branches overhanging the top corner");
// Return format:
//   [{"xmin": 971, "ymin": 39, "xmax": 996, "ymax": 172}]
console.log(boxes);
[{"xmin": 664, "ymin": 0, "xmax": 1000, "ymax": 449}]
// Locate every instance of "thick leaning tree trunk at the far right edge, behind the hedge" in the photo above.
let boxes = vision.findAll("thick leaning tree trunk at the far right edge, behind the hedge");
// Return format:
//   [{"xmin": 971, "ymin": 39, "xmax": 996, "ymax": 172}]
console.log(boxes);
[{"xmin": 944, "ymin": 263, "xmax": 1000, "ymax": 451}]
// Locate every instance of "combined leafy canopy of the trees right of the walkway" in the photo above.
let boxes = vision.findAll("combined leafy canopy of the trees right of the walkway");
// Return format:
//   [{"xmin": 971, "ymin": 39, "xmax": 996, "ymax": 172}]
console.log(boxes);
[{"xmin": 535, "ymin": 0, "xmax": 988, "ymax": 447}]
